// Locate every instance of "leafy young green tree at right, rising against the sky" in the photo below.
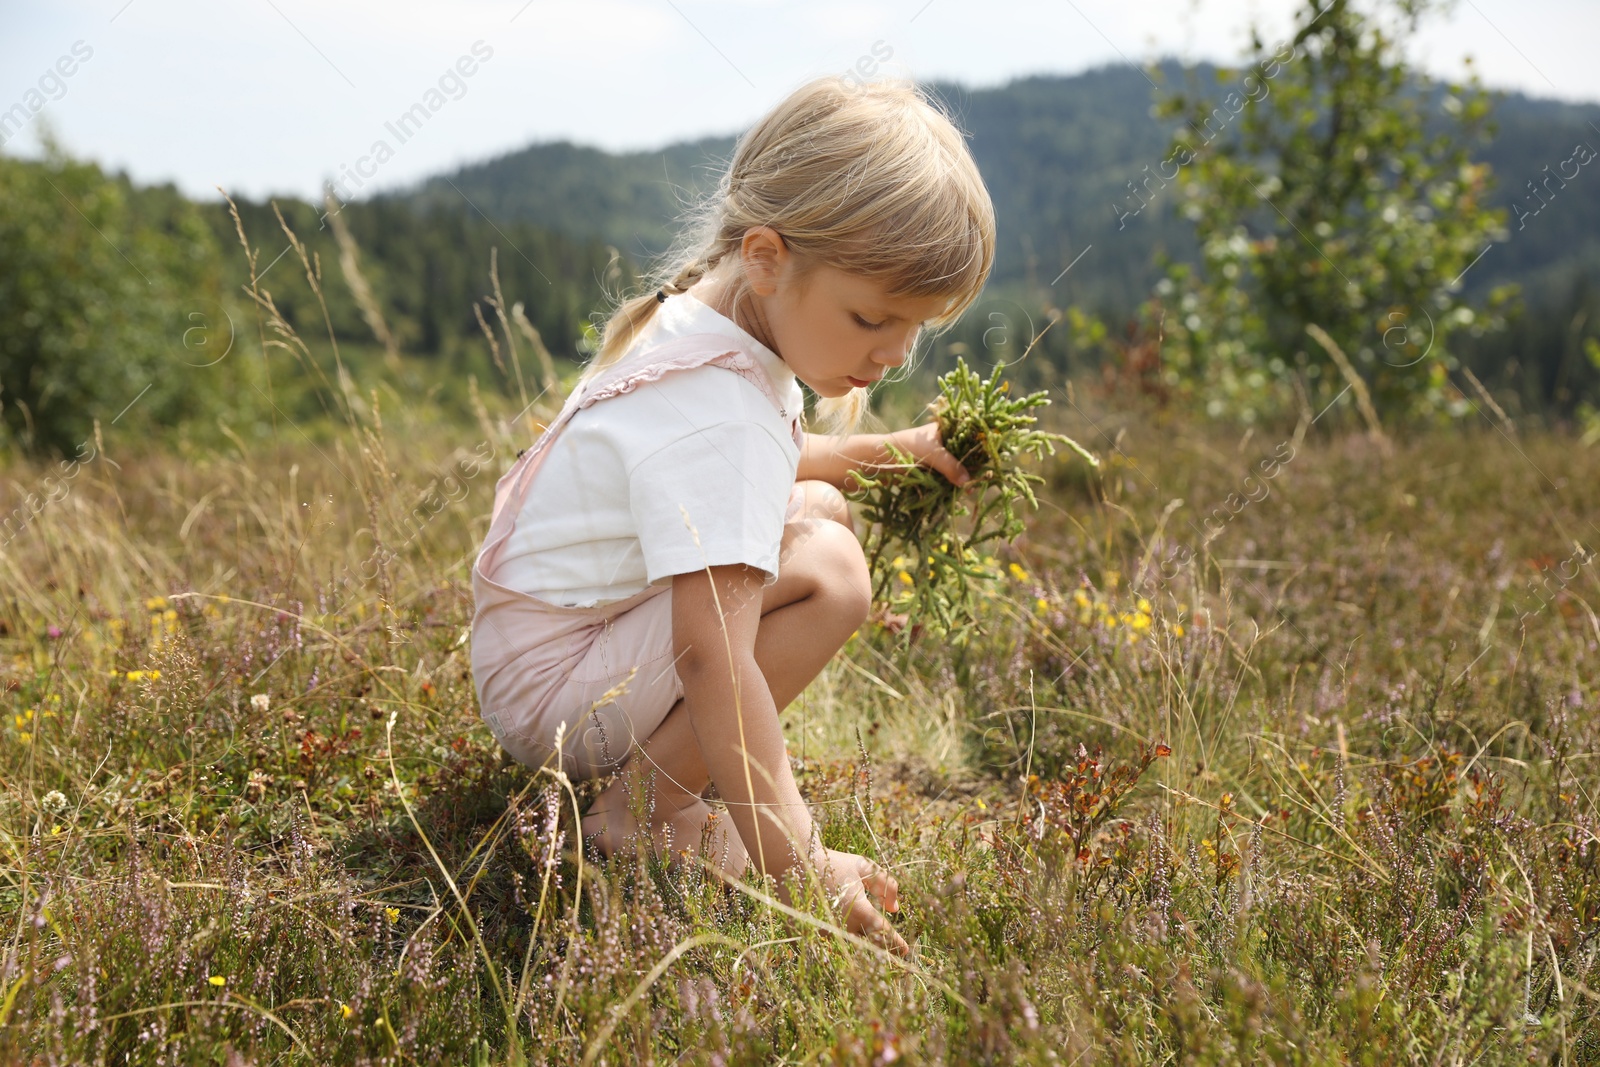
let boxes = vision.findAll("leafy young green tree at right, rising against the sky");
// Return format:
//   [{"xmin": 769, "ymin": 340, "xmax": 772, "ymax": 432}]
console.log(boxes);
[{"xmin": 1157, "ymin": 0, "xmax": 1515, "ymax": 421}]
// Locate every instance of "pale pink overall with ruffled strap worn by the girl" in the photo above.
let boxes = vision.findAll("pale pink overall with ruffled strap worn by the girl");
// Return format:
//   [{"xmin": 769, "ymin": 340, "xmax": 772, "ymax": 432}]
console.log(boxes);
[{"xmin": 472, "ymin": 334, "xmax": 803, "ymax": 779}]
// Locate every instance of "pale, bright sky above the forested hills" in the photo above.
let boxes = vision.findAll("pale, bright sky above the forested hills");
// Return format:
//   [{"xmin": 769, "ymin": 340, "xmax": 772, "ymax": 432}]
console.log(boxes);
[{"xmin": 0, "ymin": 0, "xmax": 1600, "ymax": 198}]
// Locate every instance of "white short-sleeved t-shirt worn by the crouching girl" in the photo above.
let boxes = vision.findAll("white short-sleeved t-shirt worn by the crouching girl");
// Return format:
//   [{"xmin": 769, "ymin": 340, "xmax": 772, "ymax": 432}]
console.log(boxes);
[{"xmin": 496, "ymin": 291, "xmax": 805, "ymax": 606}]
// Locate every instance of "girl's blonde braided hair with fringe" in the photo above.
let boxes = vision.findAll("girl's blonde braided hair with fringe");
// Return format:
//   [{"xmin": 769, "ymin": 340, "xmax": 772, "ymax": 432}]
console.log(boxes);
[{"xmin": 579, "ymin": 75, "xmax": 995, "ymax": 434}]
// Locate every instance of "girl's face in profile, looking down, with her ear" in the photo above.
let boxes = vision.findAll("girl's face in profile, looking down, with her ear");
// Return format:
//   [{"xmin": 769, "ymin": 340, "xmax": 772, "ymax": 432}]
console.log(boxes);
[{"xmin": 725, "ymin": 227, "xmax": 949, "ymax": 397}]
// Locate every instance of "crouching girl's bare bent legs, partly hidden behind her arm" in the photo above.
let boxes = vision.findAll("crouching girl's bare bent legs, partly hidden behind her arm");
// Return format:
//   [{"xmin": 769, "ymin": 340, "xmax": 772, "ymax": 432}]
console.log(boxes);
[{"xmin": 584, "ymin": 482, "xmax": 870, "ymax": 875}]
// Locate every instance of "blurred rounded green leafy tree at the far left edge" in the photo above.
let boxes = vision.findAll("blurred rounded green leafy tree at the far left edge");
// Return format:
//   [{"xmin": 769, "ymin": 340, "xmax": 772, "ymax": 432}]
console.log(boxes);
[{"xmin": 0, "ymin": 133, "xmax": 243, "ymax": 454}]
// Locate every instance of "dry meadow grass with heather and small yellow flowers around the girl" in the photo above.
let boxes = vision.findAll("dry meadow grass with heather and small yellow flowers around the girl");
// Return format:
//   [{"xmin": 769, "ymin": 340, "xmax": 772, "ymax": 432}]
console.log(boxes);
[{"xmin": 0, "ymin": 363, "xmax": 1600, "ymax": 1064}]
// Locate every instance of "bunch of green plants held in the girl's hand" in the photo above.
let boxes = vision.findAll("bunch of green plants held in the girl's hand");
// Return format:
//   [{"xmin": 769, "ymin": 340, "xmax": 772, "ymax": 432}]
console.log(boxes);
[{"xmin": 845, "ymin": 358, "xmax": 1099, "ymax": 641}]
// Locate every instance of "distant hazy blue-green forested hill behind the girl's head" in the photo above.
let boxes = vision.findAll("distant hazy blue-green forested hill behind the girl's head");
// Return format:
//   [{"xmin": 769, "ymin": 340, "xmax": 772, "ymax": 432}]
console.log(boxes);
[{"xmin": 395, "ymin": 62, "xmax": 1600, "ymax": 319}]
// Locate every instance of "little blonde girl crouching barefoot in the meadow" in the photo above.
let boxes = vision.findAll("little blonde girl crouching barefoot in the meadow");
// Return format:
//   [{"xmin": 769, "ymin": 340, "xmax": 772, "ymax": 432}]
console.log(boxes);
[{"xmin": 472, "ymin": 77, "xmax": 995, "ymax": 952}]
